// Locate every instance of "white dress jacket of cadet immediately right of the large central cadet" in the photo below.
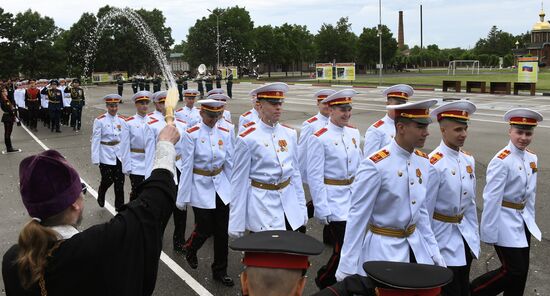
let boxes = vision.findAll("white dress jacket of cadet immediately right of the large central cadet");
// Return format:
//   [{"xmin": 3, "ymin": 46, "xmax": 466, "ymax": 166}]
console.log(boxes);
[{"xmin": 307, "ymin": 121, "xmax": 362, "ymax": 222}]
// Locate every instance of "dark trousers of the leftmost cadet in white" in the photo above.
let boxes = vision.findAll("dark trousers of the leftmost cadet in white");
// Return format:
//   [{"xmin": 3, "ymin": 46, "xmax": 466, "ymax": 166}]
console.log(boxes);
[{"xmin": 97, "ymin": 158, "xmax": 124, "ymax": 211}]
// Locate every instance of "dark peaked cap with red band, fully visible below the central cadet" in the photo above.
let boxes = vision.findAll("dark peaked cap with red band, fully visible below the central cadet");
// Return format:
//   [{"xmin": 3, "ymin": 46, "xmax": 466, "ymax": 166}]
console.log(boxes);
[{"xmin": 229, "ymin": 230, "xmax": 324, "ymax": 269}]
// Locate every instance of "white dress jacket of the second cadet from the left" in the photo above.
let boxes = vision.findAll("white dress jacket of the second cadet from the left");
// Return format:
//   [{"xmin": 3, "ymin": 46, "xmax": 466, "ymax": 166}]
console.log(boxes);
[{"xmin": 120, "ymin": 114, "xmax": 149, "ymax": 176}]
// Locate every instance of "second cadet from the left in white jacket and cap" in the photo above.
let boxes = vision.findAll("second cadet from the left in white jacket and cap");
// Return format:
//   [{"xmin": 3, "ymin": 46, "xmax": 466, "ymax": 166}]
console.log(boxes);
[{"xmin": 120, "ymin": 90, "xmax": 153, "ymax": 201}]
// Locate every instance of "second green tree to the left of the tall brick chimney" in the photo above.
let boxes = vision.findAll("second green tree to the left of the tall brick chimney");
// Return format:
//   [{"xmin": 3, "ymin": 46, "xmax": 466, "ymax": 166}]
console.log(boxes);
[{"xmin": 315, "ymin": 17, "xmax": 357, "ymax": 62}]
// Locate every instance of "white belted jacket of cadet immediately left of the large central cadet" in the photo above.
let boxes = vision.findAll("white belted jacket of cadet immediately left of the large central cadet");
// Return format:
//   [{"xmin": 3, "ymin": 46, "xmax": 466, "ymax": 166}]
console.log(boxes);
[{"xmin": 176, "ymin": 119, "xmax": 233, "ymax": 210}]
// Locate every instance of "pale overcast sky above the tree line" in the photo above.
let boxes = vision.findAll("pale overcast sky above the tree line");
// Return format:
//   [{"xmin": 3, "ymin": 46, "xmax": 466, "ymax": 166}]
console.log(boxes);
[{"xmin": 1, "ymin": 0, "xmax": 550, "ymax": 48}]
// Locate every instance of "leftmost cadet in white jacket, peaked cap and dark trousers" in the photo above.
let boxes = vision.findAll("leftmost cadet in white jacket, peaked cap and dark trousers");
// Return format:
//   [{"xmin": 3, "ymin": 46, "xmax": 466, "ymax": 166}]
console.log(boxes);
[{"xmin": 92, "ymin": 94, "xmax": 124, "ymax": 211}]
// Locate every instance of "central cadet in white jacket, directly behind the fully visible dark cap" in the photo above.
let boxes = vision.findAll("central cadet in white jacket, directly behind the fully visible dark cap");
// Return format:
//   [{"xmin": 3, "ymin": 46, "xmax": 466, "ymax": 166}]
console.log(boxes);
[{"xmin": 229, "ymin": 83, "xmax": 307, "ymax": 237}]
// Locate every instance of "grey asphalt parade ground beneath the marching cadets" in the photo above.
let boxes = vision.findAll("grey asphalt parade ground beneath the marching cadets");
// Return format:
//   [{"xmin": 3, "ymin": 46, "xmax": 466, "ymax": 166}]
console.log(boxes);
[{"xmin": 0, "ymin": 83, "xmax": 550, "ymax": 295}]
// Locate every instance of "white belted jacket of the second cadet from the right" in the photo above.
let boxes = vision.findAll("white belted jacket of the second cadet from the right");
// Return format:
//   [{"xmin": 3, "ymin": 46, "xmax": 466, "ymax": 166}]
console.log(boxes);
[{"xmin": 428, "ymin": 142, "xmax": 479, "ymax": 266}]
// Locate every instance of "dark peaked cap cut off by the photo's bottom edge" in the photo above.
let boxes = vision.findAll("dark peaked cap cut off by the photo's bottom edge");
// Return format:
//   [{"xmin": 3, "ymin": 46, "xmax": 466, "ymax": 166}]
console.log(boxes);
[{"xmin": 363, "ymin": 261, "xmax": 453, "ymax": 296}]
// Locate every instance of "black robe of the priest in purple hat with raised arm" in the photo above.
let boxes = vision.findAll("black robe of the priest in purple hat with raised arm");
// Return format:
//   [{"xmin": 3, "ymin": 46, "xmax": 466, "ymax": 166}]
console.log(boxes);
[{"xmin": 2, "ymin": 169, "xmax": 177, "ymax": 296}]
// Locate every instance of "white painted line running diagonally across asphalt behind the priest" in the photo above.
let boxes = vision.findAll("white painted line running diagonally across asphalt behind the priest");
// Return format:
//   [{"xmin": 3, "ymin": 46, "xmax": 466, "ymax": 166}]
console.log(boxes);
[{"xmin": 21, "ymin": 124, "xmax": 213, "ymax": 296}]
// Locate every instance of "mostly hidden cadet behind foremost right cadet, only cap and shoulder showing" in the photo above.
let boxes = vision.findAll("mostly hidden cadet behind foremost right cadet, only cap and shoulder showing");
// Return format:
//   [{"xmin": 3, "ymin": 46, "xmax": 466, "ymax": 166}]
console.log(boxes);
[{"xmin": 363, "ymin": 84, "xmax": 414, "ymax": 157}]
